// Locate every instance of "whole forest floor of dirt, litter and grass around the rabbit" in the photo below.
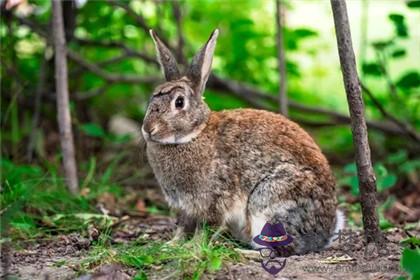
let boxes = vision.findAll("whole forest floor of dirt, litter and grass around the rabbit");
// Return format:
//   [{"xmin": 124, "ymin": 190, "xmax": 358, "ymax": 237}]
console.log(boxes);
[{"xmin": 0, "ymin": 153, "xmax": 420, "ymax": 280}]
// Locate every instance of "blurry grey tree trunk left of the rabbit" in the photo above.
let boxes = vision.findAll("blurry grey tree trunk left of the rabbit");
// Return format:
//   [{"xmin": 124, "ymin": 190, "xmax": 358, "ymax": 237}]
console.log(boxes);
[{"xmin": 52, "ymin": 0, "xmax": 79, "ymax": 193}]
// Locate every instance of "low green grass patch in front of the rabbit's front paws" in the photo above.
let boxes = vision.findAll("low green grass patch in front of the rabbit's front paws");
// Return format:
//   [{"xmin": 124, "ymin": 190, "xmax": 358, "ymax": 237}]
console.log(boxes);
[{"xmin": 82, "ymin": 227, "xmax": 240, "ymax": 279}]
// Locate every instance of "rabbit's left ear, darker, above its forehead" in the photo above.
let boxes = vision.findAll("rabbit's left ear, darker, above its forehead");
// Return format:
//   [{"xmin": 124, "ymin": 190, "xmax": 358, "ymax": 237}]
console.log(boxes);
[{"xmin": 150, "ymin": 29, "xmax": 181, "ymax": 81}]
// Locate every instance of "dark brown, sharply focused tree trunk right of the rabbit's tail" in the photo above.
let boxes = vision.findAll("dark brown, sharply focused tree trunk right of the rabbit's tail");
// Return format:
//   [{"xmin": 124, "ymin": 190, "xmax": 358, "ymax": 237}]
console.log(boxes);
[{"xmin": 331, "ymin": 0, "xmax": 383, "ymax": 244}]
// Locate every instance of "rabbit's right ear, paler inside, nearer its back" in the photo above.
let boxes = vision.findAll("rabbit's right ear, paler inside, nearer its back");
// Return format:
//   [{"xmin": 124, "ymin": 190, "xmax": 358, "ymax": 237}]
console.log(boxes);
[{"xmin": 187, "ymin": 29, "xmax": 219, "ymax": 95}]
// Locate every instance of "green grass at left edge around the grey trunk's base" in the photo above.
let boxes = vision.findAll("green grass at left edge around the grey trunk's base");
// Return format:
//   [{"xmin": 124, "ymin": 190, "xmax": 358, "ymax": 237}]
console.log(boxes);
[{"xmin": 0, "ymin": 159, "xmax": 122, "ymax": 239}]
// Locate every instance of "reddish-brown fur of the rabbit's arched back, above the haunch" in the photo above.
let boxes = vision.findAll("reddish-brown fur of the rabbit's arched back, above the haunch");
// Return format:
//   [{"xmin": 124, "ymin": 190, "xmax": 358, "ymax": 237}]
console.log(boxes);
[{"xmin": 209, "ymin": 109, "xmax": 335, "ymax": 191}]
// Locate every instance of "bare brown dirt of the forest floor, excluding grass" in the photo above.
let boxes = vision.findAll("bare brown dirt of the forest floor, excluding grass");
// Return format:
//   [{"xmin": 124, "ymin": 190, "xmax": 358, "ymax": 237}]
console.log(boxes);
[{"xmin": 2, "ymin": 217, "xmax": 419, "ymax": 280}]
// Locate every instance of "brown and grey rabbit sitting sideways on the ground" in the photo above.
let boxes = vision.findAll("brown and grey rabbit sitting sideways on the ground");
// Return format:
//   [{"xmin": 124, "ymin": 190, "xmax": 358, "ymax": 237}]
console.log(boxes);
[{"xmin": 141, "ymin": 29, "xmax": 344, "ymax": 254}]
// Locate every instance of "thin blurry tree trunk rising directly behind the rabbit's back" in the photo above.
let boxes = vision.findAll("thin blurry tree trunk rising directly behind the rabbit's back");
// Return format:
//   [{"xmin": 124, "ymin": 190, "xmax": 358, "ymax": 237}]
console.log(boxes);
[{"xmin": 276, "ymin": 0, "xmax": 288, "ymax": 116}]
